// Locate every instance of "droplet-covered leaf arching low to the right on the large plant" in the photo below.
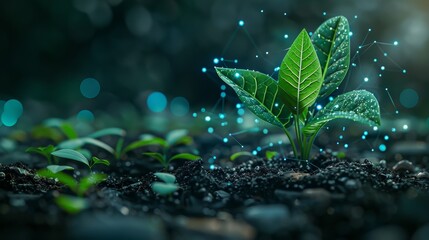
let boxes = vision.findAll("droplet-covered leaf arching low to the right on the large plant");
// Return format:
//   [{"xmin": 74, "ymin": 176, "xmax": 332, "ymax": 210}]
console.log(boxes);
[{"xmin": 303, "ymin": 90, "xmax": 380, "ymax": 136}]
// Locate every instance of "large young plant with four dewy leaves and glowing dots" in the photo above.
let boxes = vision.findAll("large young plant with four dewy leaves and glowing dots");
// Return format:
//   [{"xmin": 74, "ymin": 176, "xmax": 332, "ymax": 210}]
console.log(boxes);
[{"xmin": 216, "ymin": 16, "xmax": 380, "ymax": 160}]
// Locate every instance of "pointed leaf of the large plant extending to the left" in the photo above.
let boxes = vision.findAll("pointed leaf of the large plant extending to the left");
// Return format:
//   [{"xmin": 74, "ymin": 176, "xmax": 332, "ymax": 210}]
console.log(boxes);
[{"xmin": 216, "ymin": 68, "xmax": 290, "ymax": 128}]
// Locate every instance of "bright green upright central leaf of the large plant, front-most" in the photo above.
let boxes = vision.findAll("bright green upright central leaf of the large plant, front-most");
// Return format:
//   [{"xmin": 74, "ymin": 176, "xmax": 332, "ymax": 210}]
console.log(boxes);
[{"xmin": 279, "ymin": 29, "xmax": 323, "ymax": 116}]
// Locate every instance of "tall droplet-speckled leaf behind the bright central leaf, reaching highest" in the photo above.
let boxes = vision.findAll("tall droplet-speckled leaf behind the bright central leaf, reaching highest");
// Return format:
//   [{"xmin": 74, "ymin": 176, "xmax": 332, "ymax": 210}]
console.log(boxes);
[{"xmin": 311, "ymin": 16, "xmax": 350, "ymax": 98}]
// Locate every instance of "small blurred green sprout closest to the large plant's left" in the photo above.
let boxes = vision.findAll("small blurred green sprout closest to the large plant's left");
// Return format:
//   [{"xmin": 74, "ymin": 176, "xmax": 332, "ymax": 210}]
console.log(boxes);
[{"xmin": 117, "ymin": 129, "xmax": 201, "ymax": 169}]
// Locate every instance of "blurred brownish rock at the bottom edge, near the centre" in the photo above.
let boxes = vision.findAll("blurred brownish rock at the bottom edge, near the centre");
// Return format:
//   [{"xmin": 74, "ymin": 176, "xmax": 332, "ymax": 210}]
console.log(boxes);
[{"xmin": 175, "ymin": 217, "xmax": 255, "ymax": 240}]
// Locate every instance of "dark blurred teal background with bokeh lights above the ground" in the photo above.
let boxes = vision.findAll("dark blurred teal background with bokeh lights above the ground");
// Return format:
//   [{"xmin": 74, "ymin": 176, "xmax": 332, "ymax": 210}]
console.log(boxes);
[{"xmin": 0, "ymin": 0, "xmax": 429, "ymax": 123}]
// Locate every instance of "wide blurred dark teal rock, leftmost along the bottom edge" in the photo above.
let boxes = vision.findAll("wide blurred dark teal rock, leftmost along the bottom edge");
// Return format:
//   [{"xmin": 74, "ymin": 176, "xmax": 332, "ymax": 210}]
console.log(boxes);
[{"xmin": 65, "ymin": 213, "xmax": 167, "ymax": 240}]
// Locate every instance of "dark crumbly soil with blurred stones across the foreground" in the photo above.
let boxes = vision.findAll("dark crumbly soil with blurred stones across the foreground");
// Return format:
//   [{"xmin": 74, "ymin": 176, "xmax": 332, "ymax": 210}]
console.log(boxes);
[{"xmin": 0, "ymin": 136, "xmax": 429, "ymax": 240}]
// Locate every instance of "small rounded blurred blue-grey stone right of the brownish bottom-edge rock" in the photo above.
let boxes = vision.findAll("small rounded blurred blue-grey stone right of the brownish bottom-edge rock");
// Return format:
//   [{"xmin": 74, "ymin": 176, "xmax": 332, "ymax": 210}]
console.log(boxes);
[{"xmin": 244, "ymin": 204, "xmax": 290, "ymax": 234}]
